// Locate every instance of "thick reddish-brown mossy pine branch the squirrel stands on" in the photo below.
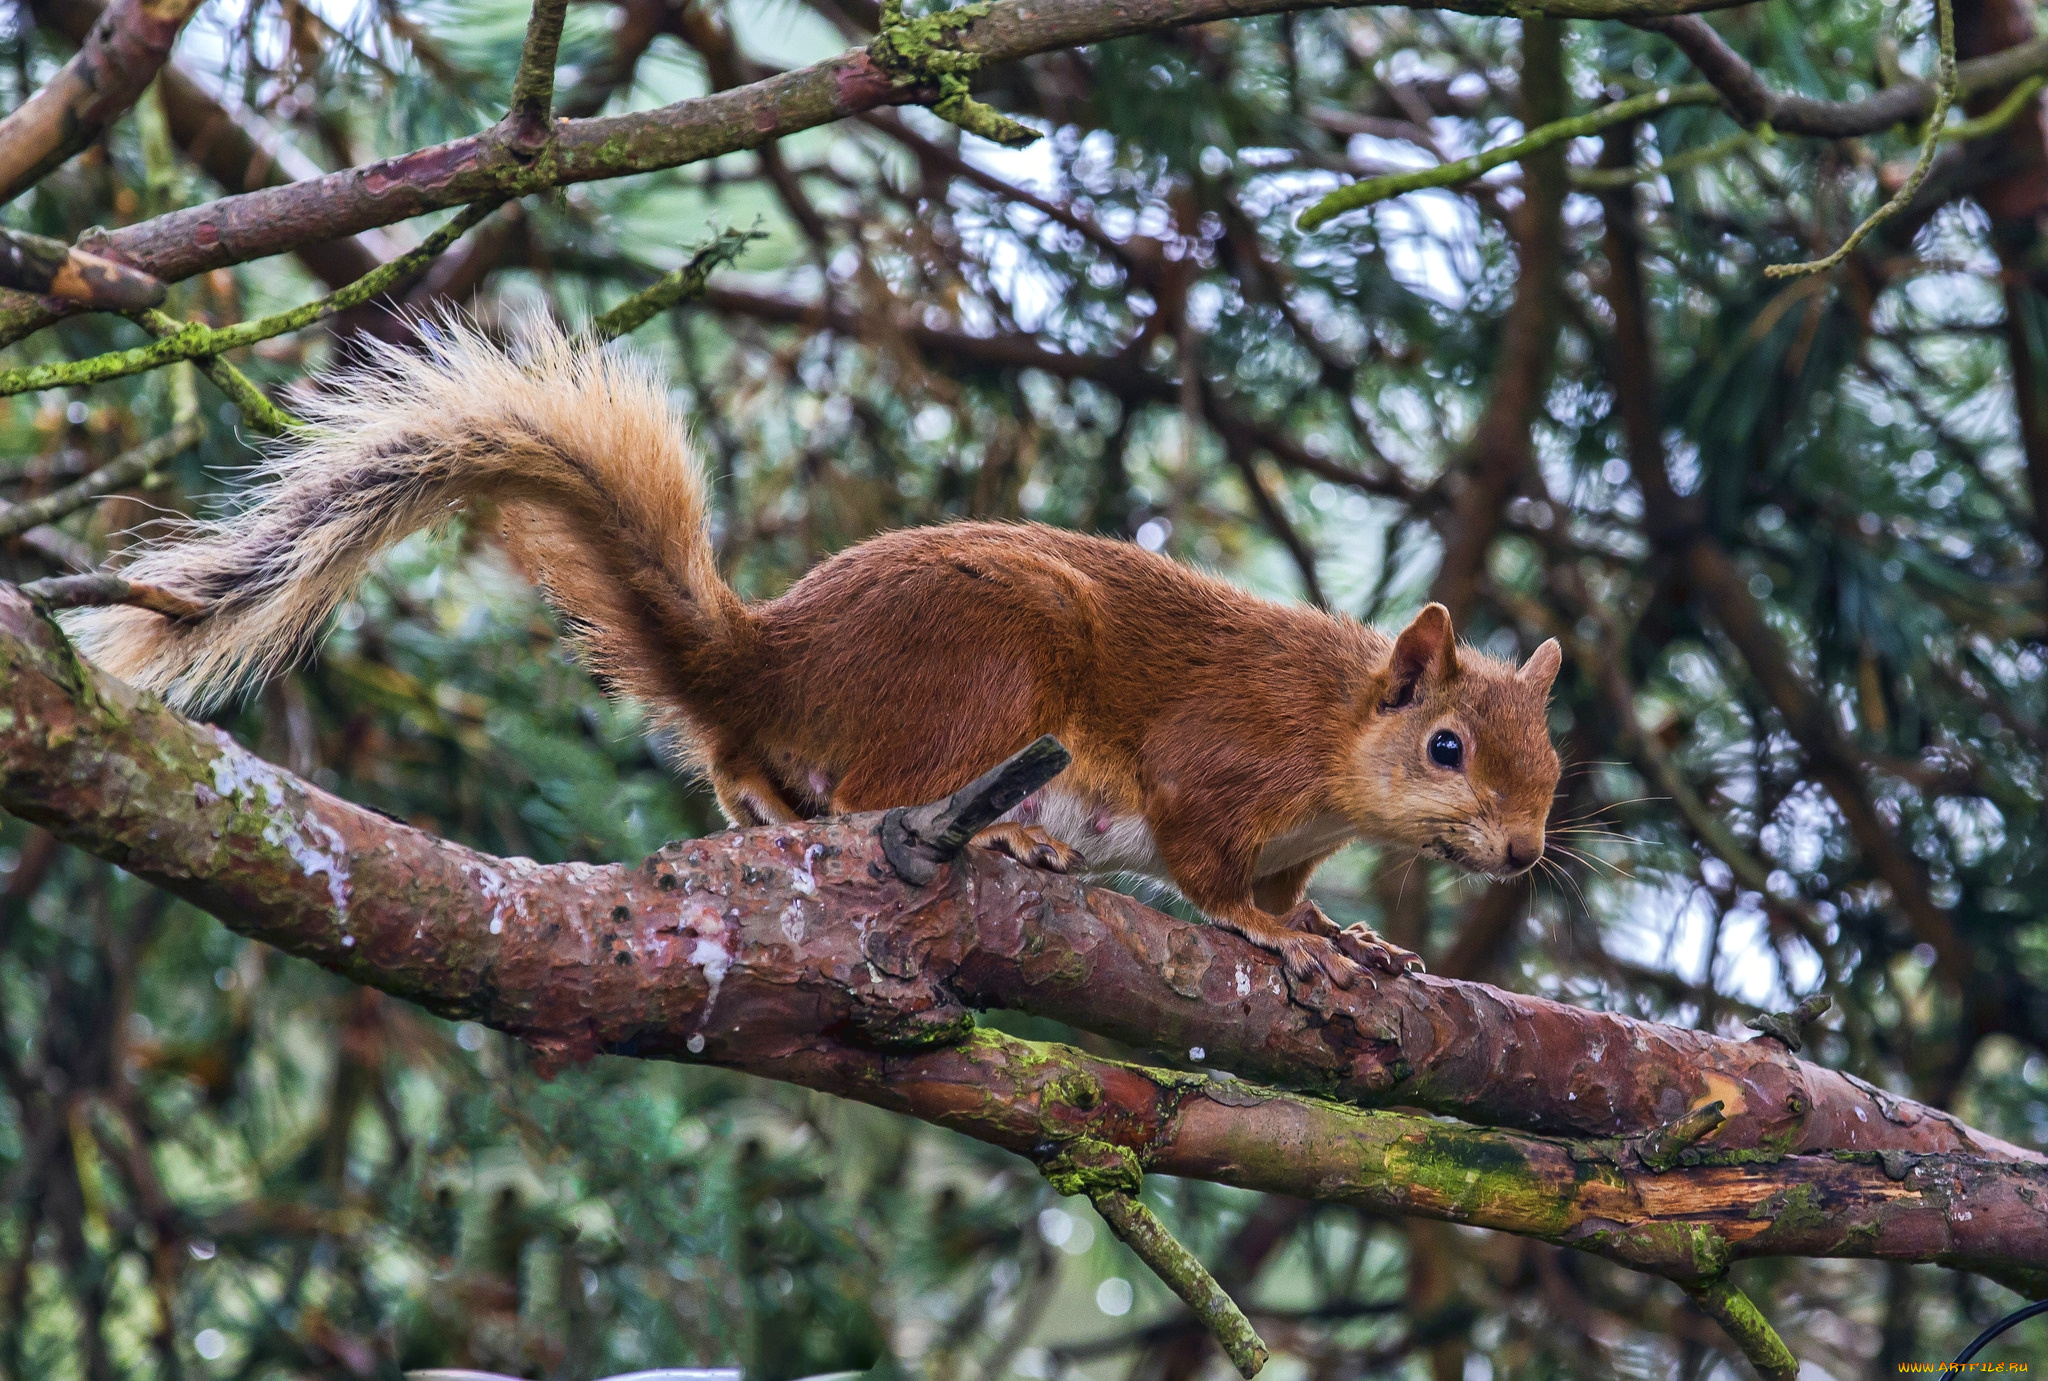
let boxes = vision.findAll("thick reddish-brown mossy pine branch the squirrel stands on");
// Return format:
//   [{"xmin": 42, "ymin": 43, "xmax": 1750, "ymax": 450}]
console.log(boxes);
[{"xmin": 0, "ymin": 588, "xmax": 2048, "ymax": 1293}]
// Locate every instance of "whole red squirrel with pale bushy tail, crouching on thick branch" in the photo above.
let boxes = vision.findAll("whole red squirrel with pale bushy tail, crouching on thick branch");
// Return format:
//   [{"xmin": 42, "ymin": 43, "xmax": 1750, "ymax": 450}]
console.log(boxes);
[{"xmin": 63, "ymin": 318, "xmax": 1561, "ymax": 988}]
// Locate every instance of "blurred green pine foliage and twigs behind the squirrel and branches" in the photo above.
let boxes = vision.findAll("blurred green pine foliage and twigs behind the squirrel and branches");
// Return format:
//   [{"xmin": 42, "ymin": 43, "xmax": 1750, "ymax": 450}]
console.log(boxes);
[{"xmin": 0, "ymin": 0, "xmax": 2048, "ymax": 1381}]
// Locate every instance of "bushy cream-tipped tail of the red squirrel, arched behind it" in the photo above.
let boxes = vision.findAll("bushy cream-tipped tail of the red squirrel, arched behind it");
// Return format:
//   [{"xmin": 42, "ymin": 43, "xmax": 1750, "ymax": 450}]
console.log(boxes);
[{"xmin": 63, "ymin": 318, "xmax": 745, "ymax": 717}]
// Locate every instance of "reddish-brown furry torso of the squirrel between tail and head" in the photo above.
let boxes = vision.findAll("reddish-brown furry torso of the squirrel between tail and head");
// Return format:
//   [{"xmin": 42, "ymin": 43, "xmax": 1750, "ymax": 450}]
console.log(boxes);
[{"xmin": 735, "ymin": 522, "xmax": 1389, "ymax": 809}]
